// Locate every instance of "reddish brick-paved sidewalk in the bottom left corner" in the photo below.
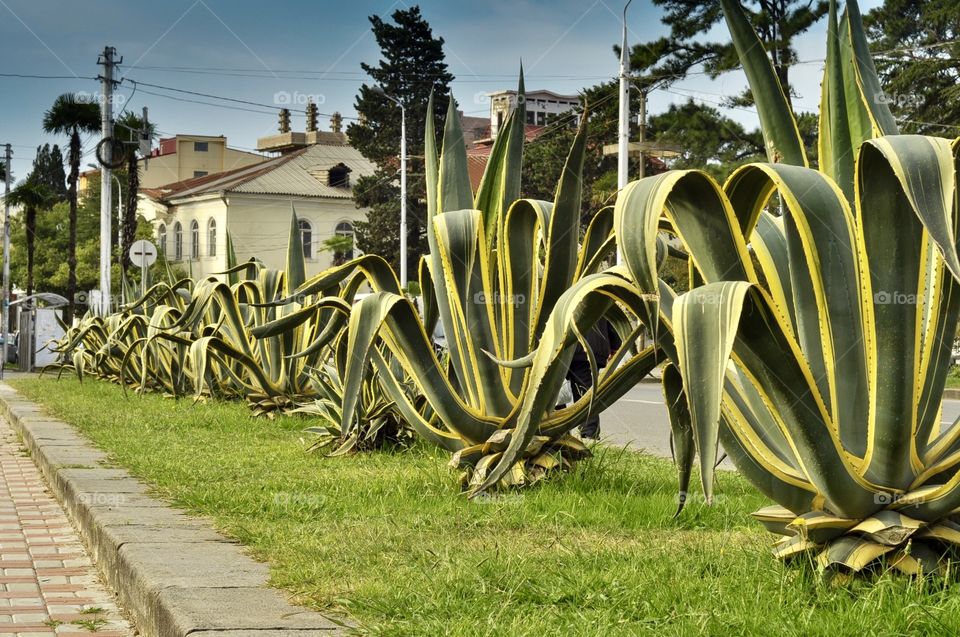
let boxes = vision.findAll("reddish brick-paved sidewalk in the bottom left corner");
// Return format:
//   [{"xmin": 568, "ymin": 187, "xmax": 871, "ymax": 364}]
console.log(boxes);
[{"xmin": 0, "ymin": 418, "xmax": 133, "ymax": 637}]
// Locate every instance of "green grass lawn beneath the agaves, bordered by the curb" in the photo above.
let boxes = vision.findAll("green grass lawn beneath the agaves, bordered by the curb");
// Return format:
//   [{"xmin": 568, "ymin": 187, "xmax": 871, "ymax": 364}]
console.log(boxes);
[{"xmin": 11, "ymin": 378, "xmax": 960, "ymax": 637}]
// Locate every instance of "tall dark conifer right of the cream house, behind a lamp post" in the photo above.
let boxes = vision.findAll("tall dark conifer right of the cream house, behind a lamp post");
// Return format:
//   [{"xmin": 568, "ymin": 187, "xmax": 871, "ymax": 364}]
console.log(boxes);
[{"xmin": 347, "ymin": 6, "xmax": 453, "ymax": 272}]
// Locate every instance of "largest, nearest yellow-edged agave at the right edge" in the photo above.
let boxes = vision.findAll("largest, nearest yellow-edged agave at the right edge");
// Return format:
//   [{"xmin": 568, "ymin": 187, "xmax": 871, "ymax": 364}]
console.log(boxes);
[{"xmin": 616, "ymin": 0, "xmax": 960, "ymax": 573}]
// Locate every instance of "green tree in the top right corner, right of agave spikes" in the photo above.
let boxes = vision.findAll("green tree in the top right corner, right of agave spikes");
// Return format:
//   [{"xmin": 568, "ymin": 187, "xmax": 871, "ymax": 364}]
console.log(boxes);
[{"xmin": 864, "ymin": 0, "xmax": 960, "ymax": 137}]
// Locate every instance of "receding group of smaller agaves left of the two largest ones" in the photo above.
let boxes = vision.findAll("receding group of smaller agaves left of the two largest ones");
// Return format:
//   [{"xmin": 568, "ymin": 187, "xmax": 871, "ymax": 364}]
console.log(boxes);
[{"xmin": 55, "ymin": 217, "xmax": 414, "ymax": 454}]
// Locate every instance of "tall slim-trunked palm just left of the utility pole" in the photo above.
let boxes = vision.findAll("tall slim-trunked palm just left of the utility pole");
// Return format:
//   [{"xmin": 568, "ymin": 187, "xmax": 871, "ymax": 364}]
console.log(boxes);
[{"xmin": 43, "ymin": 93, "xmax": 100, "ymax": 324}]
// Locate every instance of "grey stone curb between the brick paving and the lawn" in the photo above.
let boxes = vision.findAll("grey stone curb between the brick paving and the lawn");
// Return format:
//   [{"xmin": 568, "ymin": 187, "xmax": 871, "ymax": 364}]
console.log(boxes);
[{"xmin": 0, "ymin": 383, "xmax": 348, "ymax": 637}]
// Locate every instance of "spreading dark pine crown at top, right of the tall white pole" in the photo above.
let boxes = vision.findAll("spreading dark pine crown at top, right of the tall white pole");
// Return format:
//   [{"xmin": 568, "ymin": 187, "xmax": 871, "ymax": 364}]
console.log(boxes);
[{"xmin": 630, "ymin": 0, "xmax": 828, "ymax": 105}]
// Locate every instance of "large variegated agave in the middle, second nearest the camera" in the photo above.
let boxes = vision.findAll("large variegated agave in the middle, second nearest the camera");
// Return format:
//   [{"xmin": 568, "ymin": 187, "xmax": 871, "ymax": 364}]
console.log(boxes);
[{"xmin": 297, "ymin": 73, "xmax": 658, "ymax": 494}]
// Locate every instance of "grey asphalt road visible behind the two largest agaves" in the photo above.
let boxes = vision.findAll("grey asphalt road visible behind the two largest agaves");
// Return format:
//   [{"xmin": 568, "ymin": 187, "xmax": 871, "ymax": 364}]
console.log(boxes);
[{"xmin": 600, "ymin": 383, "xmax": 960, "ymax": 457}]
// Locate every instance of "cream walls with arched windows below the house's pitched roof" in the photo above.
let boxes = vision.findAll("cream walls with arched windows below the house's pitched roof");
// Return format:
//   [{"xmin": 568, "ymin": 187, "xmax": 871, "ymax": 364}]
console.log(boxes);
[{"xmin": 154, "ymin": 193, "xmax": 366, "ymax": 277}]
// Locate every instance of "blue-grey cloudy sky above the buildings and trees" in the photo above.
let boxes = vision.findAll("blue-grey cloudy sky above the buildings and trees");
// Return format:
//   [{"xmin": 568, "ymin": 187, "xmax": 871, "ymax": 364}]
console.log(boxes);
[{"xmin": 0, "ymin": 0, "xmax": 880, "ymax": 177}]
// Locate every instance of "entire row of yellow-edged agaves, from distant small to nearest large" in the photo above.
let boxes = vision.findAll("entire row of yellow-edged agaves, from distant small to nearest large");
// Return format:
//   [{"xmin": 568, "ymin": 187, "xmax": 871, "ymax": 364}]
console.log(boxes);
[{"xmin": 54, "ymin": 0, "xmax": 960, "ymax": 573}]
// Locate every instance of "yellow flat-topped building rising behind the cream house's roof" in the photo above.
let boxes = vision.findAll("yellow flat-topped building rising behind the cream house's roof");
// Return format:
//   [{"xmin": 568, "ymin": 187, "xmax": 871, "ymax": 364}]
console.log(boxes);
[{"xmin": 78, "ymin": 135, "xmax": 267, "ymax": 192}]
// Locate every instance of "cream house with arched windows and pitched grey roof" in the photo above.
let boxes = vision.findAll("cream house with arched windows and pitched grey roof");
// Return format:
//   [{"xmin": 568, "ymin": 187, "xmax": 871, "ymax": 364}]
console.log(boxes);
[{"xmin": 138, "ymin": 140, "xmax": 375, "ymax": 277}]
